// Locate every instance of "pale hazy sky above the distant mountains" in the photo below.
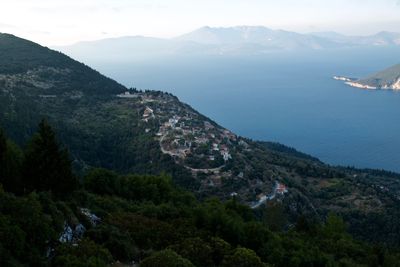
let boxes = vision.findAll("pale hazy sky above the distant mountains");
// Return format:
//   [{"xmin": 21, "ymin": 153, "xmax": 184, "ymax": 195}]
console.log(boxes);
[{"xmin": 0, "ymin": 0, "xmax": 400, "ymax": 45}]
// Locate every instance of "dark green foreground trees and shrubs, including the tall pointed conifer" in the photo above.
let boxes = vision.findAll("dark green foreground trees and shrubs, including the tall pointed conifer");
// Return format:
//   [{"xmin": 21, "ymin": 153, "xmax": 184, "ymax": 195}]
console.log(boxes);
[{"xmin": 0, "ymin": 121, "xmax": 400, "ymax": 267}]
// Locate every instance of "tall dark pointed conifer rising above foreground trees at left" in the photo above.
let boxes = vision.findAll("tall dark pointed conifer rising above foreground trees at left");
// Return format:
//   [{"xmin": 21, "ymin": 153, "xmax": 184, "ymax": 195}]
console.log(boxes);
[{"xmin": 23, "ymin": 120, "xmax": 77, "ymax": 196}]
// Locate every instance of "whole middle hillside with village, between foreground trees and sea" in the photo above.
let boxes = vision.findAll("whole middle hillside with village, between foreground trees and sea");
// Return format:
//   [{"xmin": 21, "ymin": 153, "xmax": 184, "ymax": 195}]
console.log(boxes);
[{"xmin": 0, "ymin": 35, "xmax": 400, "ymax": 251}]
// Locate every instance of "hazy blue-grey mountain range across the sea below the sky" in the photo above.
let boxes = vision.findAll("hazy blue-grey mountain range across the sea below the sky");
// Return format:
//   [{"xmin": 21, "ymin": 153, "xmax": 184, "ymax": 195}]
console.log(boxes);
[{"xmin": 54, "ymin": 26, "xmax": 400, "ymax": 60}]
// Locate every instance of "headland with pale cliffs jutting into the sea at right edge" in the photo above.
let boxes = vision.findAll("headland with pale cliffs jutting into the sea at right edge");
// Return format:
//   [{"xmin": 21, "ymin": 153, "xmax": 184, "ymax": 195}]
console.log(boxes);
[{"xmin": 334, "ymin": 64, "xmax": 400, "ymax": 90}]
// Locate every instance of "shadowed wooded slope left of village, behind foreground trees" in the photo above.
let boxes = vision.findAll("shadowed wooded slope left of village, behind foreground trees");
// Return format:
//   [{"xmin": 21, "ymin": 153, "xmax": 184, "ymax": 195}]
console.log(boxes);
[{"xmin": 0, "ymin": 34, "xmax": 196, "ymax": 188}]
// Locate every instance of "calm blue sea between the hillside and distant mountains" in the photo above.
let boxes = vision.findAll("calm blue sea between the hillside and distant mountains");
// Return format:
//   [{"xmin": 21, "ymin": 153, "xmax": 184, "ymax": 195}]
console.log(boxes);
[{"xmin": 90, "ymin": 47, "xmax": 400, "ymax": 172}]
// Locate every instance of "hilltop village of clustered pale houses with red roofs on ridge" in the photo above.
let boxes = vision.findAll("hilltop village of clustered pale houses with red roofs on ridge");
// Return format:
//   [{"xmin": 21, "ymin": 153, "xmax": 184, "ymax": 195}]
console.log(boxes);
[{"xmin": 119, "ymin": 92, "xmax": 288, "ymax": 204}]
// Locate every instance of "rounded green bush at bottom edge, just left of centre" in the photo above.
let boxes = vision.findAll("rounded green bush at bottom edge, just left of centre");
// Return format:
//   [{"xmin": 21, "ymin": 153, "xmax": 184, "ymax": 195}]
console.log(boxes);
[{"xmin": 140, "ymin": 249, "xmax": 194, "ymax": 267}]
